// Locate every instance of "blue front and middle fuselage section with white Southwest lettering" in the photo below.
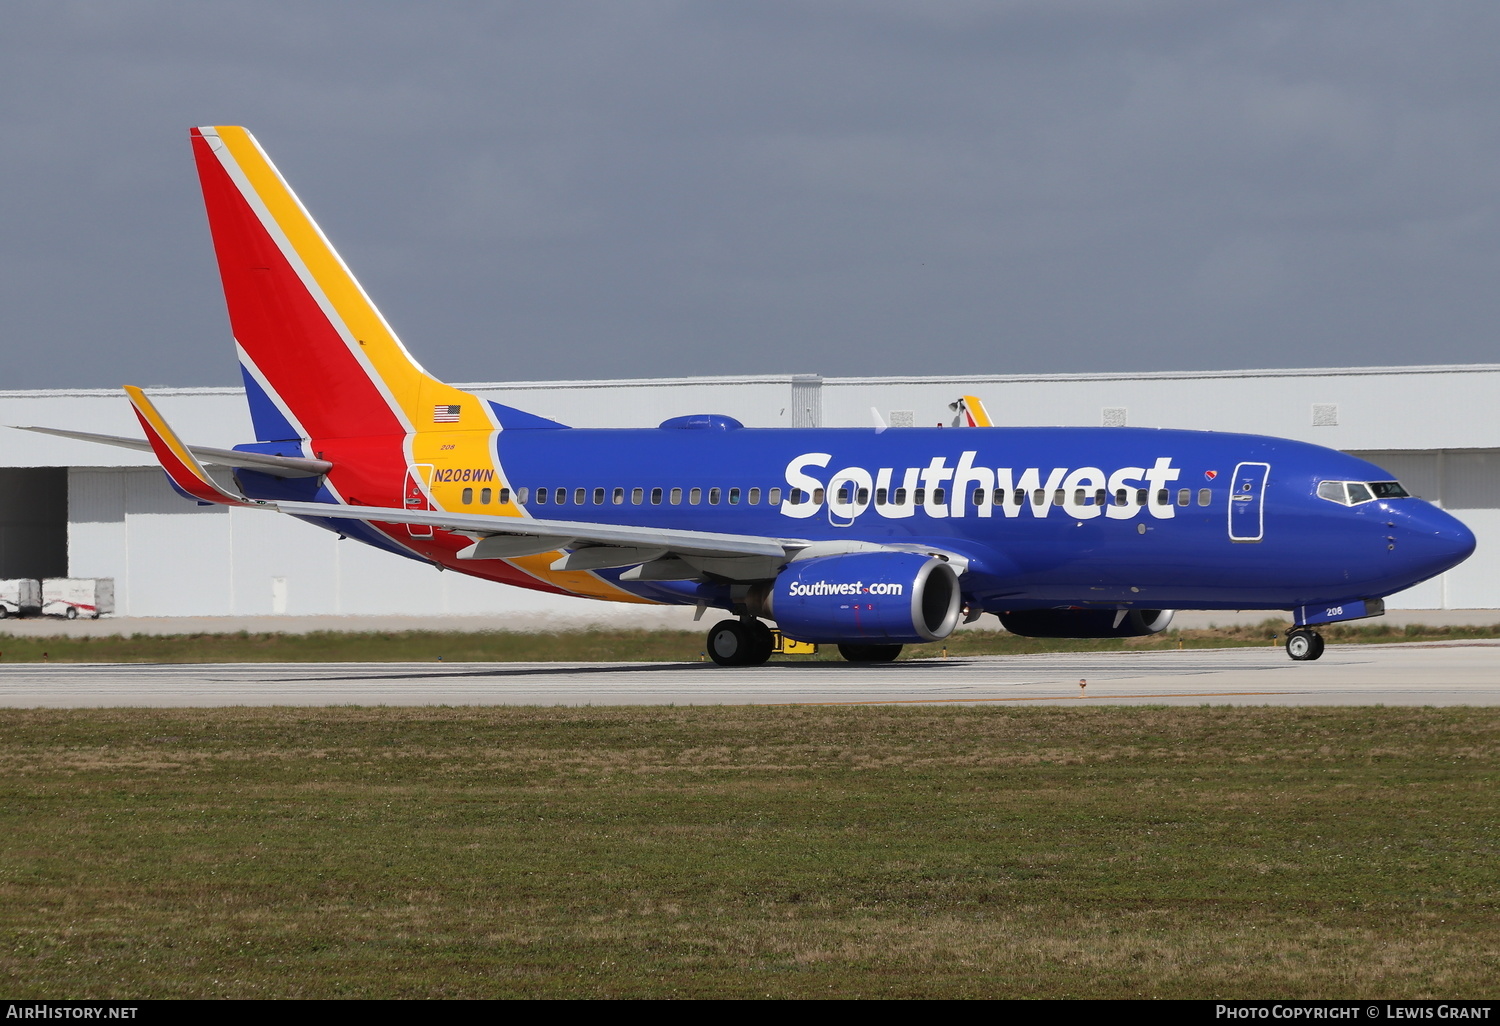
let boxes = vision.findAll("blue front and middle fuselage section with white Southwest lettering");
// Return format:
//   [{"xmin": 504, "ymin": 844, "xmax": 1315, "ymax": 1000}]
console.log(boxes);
[{"xmin": 468, "ymin": 428, "xmax": 1475, "ymax": 611}]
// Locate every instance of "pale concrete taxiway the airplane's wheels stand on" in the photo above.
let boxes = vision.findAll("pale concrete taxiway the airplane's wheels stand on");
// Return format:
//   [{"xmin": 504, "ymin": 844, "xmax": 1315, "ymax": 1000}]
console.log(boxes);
[{"xmin": 0, "ymin": 642, "xmax": 1500, "ymax": 708}]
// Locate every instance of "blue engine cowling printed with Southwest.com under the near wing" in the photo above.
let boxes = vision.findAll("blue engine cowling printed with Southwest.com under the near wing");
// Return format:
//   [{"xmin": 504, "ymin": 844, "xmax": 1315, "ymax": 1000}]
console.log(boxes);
[{"xmin": 768, "ymin": 552, "xmax": 960, "ymax": 645}]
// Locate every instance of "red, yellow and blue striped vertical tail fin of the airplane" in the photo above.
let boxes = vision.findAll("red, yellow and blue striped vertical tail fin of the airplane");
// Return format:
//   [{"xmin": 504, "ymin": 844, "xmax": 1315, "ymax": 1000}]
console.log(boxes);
[{"xmin": 192, "ymin": 126, "xmax": 473, "ymax": 441}]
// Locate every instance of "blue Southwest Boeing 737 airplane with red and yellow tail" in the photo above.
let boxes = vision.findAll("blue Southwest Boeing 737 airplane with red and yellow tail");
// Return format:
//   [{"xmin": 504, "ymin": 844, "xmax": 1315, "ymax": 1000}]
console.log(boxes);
[{"xmin": 23, "ymin": 128, "xmax": 1475, "ymax": 666}]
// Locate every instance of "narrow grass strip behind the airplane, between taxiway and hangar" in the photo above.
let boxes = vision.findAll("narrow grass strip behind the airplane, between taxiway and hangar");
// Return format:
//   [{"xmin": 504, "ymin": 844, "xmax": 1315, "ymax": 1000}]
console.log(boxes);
[{"xmin": 0, "ymin": 620, "xmax": 1500, "ymax": 663}]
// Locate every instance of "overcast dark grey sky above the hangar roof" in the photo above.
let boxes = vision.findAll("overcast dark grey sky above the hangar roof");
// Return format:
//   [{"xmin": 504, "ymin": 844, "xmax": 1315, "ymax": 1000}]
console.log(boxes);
[{"xmin": 0, "ymin": 0, "xmax": 1500, "ymax": 389}]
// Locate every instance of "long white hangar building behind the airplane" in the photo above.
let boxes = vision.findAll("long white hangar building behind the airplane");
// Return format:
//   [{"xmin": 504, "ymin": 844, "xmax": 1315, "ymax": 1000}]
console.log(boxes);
[{"xmin": 0, "ymin": 365, "xmax": 1500, "ymax": 618}]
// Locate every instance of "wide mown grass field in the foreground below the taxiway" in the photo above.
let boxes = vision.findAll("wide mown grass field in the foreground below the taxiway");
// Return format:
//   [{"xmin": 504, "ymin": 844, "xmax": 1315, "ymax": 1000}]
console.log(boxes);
[{"xmin": 0, "ymin": 707, "xmax": 1500, "ymax": 998}]
